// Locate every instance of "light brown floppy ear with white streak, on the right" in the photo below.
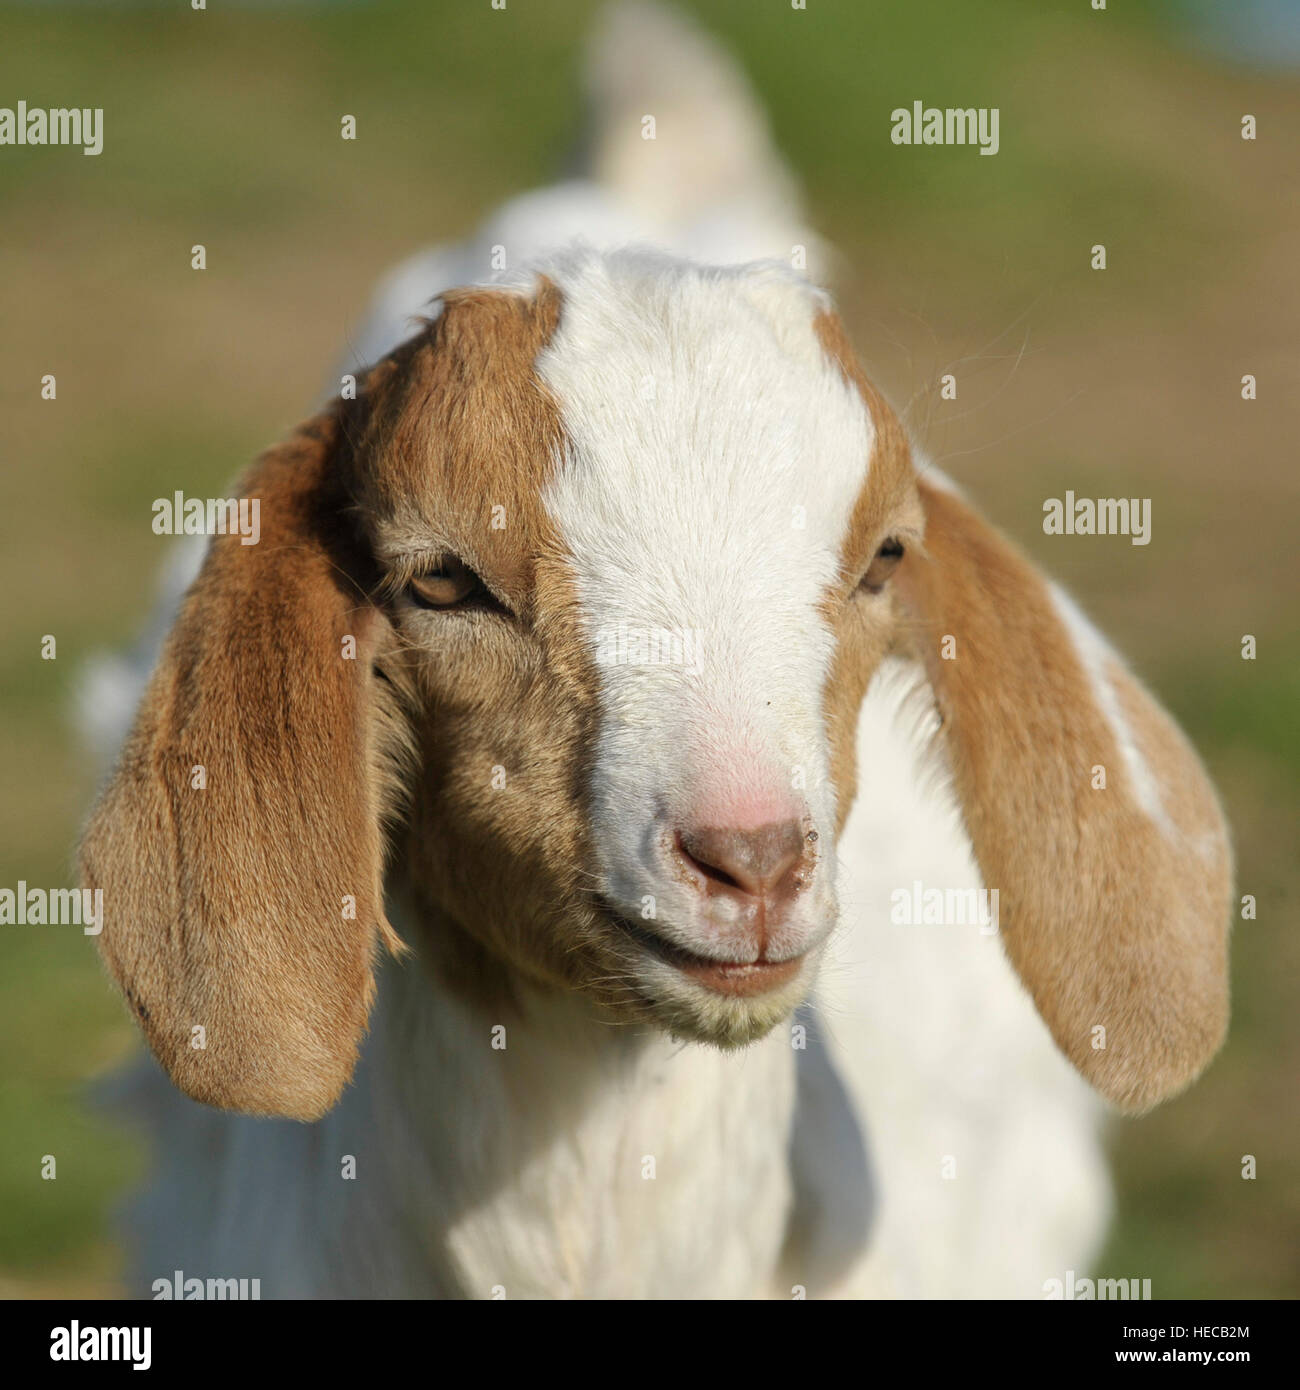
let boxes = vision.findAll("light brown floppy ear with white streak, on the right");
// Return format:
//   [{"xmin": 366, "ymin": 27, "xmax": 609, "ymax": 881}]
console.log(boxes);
[{"xmin": 897, "ymin": 482, "xmax": 1232, "ymax": 1111}]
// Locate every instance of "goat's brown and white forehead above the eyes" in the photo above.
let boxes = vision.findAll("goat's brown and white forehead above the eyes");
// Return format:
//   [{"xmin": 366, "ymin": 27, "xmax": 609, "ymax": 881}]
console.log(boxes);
[{"xmin": 359, "ymin": 256, "xmax": 911, "ymax": 626}]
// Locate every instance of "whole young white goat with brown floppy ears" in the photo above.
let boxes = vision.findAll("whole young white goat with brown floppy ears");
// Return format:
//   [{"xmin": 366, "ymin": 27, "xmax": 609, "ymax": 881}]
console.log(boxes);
[{"xmin": 82, "ymin": 2, "xmax": 1232, "ymax": 1298}]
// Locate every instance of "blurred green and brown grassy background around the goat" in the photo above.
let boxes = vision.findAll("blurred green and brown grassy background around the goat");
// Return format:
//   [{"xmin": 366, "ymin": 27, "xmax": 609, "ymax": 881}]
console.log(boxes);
[{"xmin": 0, "ymin": 0, "xmax": 1300, "ymax": 1298}]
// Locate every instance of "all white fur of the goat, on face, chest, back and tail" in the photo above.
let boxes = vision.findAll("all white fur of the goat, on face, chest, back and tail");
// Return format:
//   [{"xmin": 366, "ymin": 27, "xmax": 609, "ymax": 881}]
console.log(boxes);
[{"xmin": 86, "ymin": 6, "xmax": 1108, "ymax": 1297}]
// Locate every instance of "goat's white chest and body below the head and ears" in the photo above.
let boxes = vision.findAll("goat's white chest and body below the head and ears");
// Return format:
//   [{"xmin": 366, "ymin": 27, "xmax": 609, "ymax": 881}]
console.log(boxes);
[{"xmin": 114, "ymin": 667, "xmax": 1108, "ymax": 1298}]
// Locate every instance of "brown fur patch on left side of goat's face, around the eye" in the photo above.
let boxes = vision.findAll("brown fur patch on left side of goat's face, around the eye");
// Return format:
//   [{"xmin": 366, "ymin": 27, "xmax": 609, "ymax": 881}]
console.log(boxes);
[{"xmin": 361, "ymin": 279, "xmax": 617, "ymax": 1009}]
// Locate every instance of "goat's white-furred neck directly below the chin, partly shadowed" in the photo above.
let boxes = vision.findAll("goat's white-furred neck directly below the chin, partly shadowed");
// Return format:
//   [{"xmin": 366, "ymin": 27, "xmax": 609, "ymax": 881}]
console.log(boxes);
[{"xmin": 360, "ymin": 917, "xmax": 795, "ymax": 1297}]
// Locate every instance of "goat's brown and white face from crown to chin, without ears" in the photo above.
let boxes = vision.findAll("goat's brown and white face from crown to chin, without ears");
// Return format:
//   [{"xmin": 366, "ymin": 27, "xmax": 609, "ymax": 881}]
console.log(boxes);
[{"xmin": 357, "ymin": 259, "xmax": 920, "ymax": 1044}]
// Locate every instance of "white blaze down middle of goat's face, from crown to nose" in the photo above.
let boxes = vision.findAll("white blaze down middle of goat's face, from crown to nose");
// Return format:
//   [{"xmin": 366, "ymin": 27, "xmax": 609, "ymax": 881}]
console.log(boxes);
[{"xmin": 537, "ymin": 252, "xmax": 873, "ymax": 948}]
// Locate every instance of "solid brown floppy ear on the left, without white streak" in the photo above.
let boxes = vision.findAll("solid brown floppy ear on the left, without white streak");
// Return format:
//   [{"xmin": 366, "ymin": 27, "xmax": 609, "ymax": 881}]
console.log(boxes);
[{"xmin": 82, "ymin": 411, "xmax": 396, "ymax": 1119}]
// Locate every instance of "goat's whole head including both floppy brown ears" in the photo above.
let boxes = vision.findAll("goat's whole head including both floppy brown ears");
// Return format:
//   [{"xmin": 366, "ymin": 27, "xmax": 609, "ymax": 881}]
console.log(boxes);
[{"xmin": 85, "ymin": 254, "xmax": 1228, "ymax": 1116}]
